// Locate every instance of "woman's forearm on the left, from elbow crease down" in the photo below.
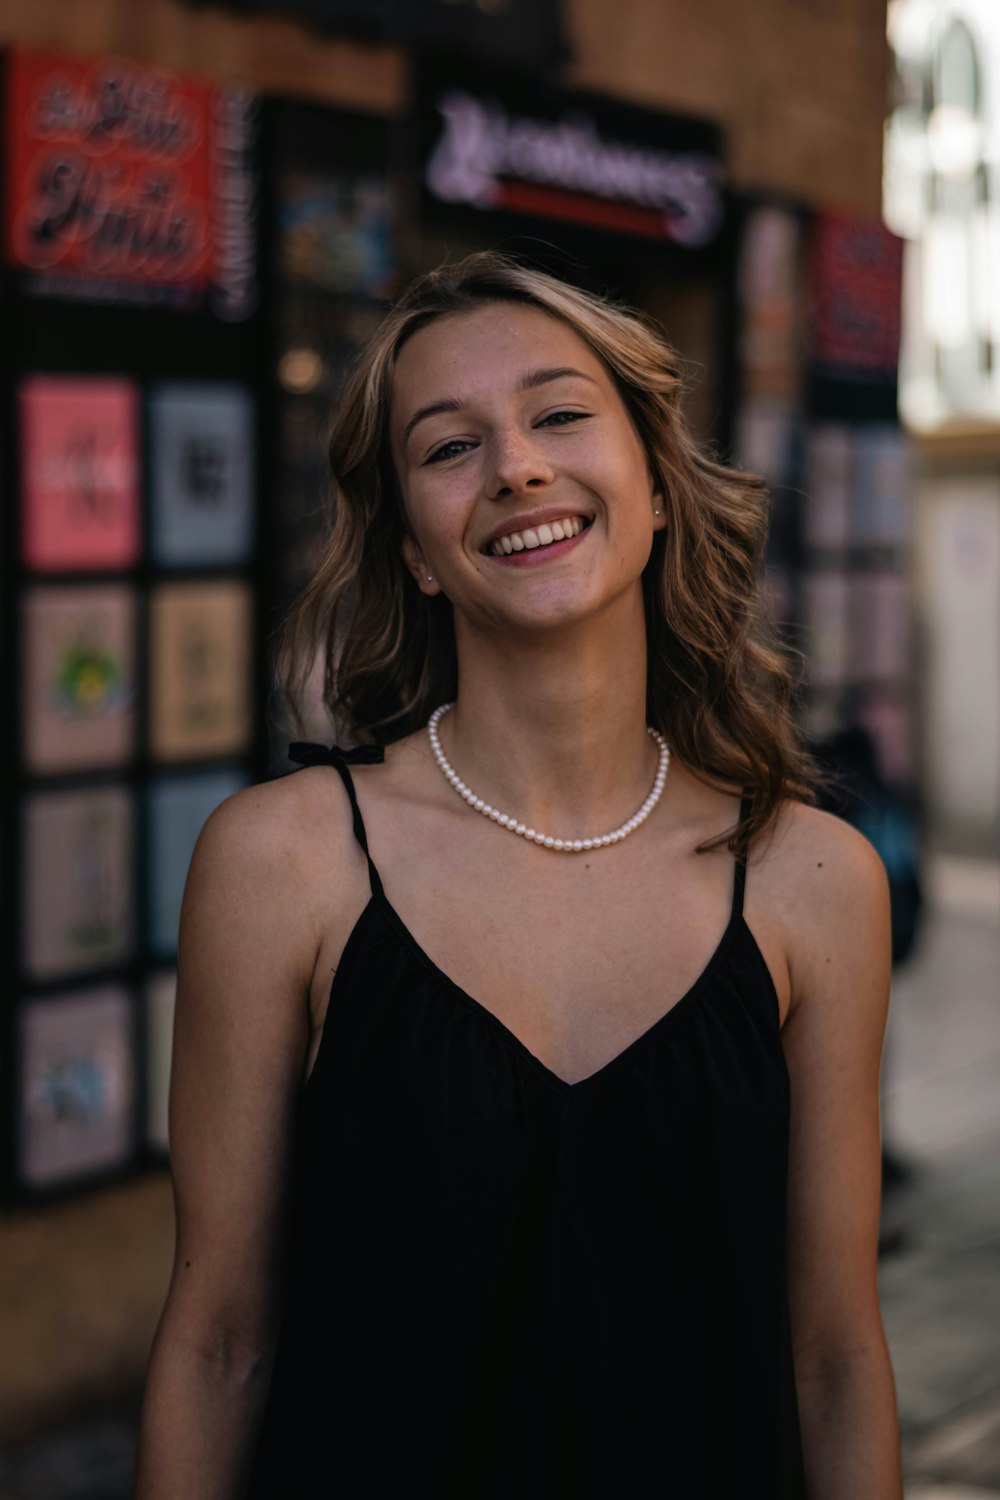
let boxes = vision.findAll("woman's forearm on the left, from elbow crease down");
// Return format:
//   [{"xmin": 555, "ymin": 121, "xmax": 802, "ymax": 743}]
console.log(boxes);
[{"xmin": 133, "ymin": 1323, "xmax": 271, "ymax": 1500}]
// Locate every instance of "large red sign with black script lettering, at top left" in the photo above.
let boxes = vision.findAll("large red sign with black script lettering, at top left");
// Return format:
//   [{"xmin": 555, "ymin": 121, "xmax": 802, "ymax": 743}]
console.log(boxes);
[{"xmin": 4, "ymin": 50, "xmax": 214, "ymax": 303}]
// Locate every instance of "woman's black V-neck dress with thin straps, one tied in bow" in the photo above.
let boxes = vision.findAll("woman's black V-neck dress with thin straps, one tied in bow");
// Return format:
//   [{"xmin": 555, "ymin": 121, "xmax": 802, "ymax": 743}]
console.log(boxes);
[{"xmin": 249, "ymin": 744, "xmax": 805, "ymax": 1500}]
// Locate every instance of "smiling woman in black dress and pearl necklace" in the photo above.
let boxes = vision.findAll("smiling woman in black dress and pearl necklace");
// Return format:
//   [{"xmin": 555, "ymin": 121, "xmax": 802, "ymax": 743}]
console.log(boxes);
[{"xmin": 136, "ymin": 254, "xmax": 901, "ymax": 1500}]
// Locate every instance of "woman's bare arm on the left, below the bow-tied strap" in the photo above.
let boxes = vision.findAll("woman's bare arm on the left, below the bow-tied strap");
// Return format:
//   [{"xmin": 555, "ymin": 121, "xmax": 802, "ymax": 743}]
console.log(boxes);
[{"xmin": 135, "ymin": 777, "xmax": 338, "ymax": 1500}]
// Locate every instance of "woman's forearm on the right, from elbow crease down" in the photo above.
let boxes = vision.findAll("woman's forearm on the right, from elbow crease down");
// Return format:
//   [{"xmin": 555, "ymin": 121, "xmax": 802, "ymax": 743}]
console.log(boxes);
[{"xmin": 795, "ymin": 1341, "xmax": 903, "ymax": 1500}]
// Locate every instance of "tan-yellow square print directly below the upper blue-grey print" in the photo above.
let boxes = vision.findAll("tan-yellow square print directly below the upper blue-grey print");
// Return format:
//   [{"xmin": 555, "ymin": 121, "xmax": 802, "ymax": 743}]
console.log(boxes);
[{"xmin": 150, "ymin": 579, "xmax": 252, "ymax": 761}]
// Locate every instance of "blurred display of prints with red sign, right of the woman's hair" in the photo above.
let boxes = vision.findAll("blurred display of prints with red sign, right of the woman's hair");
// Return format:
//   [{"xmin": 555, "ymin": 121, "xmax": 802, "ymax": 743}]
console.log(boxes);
[{"xmin": 735, "ymin": 201, "xmax": 919, "ymax": 794}]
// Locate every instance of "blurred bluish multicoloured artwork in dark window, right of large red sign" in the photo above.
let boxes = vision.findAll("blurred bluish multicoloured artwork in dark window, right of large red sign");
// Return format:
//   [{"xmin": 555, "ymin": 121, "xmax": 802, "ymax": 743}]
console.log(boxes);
[{"xmin": 279, "ymin": 173, "xmax": 396, "ymax": 297}]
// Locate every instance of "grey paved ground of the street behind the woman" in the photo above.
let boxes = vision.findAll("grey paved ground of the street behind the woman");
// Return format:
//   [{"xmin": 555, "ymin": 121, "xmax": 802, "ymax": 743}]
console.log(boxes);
[{"xmin": 0, "ymin": 860, "xmax": 1000, "ymax": 1500}]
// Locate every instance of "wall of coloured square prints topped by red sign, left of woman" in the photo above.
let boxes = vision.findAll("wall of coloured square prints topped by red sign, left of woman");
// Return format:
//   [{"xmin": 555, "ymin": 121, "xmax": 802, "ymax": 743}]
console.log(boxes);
[{"xmin": 0, "ymin": 41, "xmax": 265, "ymax": 1202}]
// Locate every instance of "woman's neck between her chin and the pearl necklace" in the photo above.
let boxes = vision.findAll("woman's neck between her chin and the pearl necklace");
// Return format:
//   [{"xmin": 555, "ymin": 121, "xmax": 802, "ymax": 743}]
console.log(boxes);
[{"xmin": 441, "ymin": 599, "xmax": 657, "ymax": 837}]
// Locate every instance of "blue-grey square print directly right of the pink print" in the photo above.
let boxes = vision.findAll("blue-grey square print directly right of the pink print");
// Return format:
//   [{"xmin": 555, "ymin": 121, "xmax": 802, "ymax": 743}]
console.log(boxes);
[{"xmin": 150, "ymin": 383, "xmax": 255, "ymax": 566}]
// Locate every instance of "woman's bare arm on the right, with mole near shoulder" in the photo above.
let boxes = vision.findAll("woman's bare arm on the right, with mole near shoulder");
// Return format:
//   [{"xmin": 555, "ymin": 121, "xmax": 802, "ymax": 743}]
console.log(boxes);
[{"xmin": 777, "ymin": 807, "xmax": 903, "ymax": 1500}]
